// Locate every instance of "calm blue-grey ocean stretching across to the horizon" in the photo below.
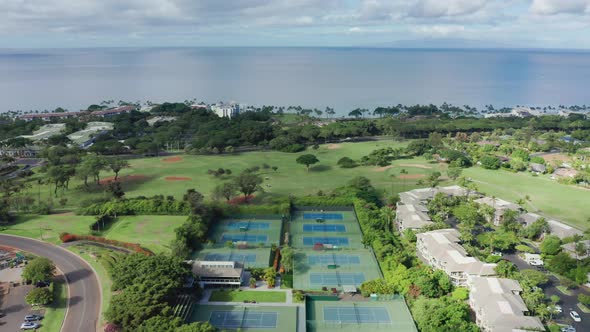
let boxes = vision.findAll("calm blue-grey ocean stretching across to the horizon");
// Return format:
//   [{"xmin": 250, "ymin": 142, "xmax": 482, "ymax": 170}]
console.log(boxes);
[{"xmin": 0, "ymin": 48, "xmax": 590, "ymax": 115}]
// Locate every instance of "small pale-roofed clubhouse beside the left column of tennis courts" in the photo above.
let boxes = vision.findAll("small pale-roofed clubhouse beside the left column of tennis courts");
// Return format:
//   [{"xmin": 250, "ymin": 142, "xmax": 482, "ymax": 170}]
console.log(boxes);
[{"xmin": 192, "ymin": 261, "xmax": 244, "ymax": 288}]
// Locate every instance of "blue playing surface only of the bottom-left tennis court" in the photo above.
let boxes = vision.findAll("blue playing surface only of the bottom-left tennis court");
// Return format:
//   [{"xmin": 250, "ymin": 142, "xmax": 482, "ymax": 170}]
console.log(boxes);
[{"xmin": 209, "ymin": 310, "xmax": 278, "ymax": 329}]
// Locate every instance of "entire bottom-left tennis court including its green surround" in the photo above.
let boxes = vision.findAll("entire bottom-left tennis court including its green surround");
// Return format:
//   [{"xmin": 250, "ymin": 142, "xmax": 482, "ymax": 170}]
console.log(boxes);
[{"xmin": 191, "ymin": 305, "xmax": 298, "ymax": 332}]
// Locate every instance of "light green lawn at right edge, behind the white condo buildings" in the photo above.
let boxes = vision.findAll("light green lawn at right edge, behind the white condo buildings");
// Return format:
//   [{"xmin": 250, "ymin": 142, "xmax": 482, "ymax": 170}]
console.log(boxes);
[{"xmin": 463, "ymin": 167, "xmax": 590, "ymax": 229}]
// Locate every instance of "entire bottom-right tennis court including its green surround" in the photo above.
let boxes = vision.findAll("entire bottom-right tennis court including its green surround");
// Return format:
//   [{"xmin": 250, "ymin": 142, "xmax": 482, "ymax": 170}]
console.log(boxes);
[{"xmin": 306, "ymin": 296, "xmax": 417, "ymax": 332}]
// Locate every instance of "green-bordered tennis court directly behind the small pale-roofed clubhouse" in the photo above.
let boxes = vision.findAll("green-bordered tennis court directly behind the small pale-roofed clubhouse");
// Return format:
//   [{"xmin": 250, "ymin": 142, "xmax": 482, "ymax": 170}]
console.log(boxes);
[{"xmin": 192, "ymin": 246, "xmax": 270, "ymax": 268}]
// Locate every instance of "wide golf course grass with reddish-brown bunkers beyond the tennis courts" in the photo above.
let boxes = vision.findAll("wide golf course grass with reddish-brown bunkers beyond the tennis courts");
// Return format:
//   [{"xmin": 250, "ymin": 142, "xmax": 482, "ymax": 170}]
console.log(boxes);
[{"xmin": 30, "ymin": 141, "xmax": 438, "ymax": 208}]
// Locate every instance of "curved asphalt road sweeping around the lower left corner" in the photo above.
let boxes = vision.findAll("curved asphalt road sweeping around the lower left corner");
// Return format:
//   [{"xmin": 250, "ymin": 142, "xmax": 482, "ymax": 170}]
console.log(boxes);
[{"xmin": 0, "ymin": 234, "xmax": 101, "ymax": 332}]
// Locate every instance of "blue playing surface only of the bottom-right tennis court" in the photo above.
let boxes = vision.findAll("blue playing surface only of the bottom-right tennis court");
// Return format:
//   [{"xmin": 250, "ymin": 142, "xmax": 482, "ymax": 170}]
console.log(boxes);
[{"xmin": 324, "ymin": 305, "xmax": 391, "ymax": 324}]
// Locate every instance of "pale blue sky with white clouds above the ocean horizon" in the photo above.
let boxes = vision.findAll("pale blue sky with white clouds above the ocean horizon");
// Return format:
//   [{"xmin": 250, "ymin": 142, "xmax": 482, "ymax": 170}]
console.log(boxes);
[{"xmin": 0, "ymin": 0, "xmax": 590, "ymax": 49}]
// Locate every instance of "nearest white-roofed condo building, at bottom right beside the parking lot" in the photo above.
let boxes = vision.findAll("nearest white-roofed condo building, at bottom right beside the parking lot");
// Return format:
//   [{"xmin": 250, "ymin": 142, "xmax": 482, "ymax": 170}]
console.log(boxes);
[{"xmin": 469, "ymin": 277, "xmax": 545, "ymax": 332}]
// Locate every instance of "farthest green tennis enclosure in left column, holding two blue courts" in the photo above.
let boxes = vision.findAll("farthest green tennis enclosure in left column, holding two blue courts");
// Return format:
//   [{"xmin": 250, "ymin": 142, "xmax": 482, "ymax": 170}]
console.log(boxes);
[{"xmin": 209, "ymin": 216, "xmax": 282, "ymax": 248}]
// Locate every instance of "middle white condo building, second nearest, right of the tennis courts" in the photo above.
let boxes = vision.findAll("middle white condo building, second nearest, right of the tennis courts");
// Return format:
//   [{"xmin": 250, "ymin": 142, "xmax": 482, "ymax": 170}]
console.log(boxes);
[{"xmin": 416, "ymin": 229, "xmax": 496, "ymax": 286}]
